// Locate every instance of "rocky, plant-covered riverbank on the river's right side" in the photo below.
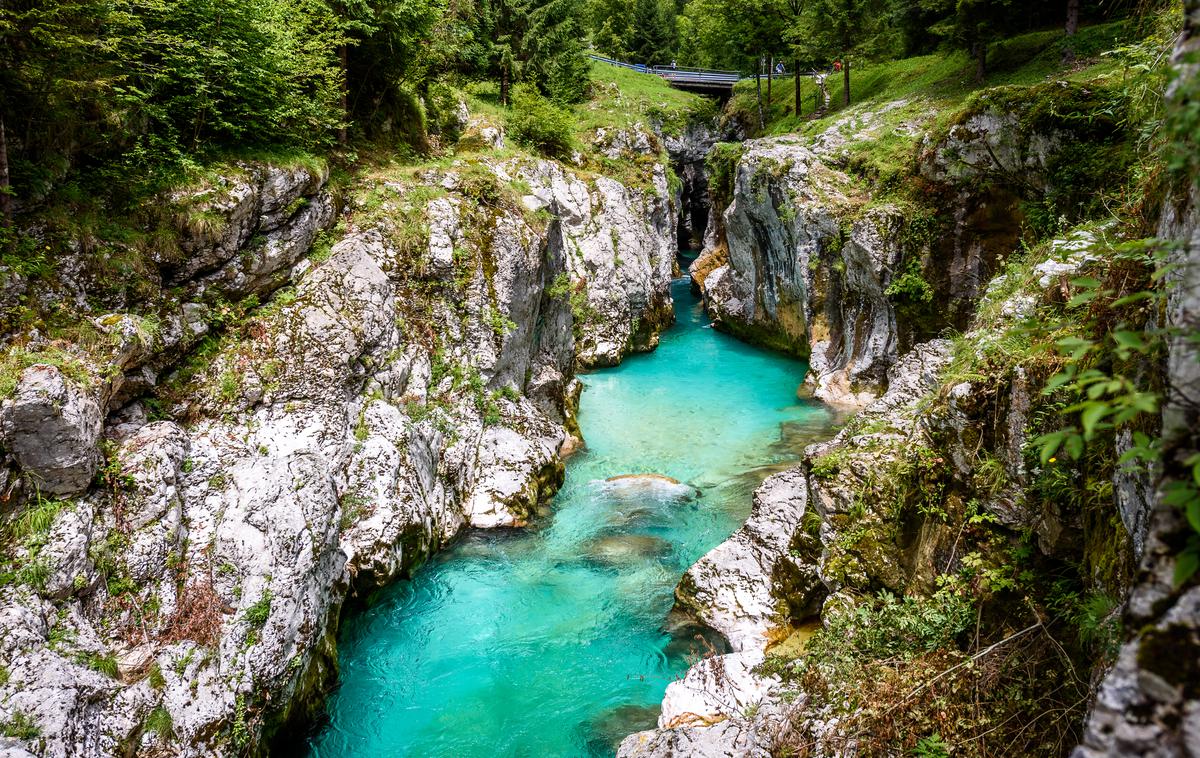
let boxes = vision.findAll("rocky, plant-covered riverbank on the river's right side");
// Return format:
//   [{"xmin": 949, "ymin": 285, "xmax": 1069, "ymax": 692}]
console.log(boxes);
[{"xmin": 618, "ymin": 2, "xmax": 1200, "ymax": 758}]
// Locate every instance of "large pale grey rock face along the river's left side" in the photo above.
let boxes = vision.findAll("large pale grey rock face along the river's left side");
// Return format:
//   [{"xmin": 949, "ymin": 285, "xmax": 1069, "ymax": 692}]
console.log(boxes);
[{"xmin": 0, "ymin": 142, "xmax": 691, "ymax": 757}]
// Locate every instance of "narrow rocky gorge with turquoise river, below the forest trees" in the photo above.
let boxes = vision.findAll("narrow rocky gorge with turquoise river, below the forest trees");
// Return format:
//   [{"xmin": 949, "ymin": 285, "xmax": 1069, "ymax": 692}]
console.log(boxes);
[{"xmin": 0, "ymin": 0, "xmax": 1200, "ymax": 758}]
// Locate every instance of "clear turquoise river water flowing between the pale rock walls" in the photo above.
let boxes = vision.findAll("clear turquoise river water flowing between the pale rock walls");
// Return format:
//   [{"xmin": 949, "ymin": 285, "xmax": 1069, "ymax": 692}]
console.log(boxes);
[{"xmin": 312, "ymin": 272, "xmax": 833, "ymax": 758}]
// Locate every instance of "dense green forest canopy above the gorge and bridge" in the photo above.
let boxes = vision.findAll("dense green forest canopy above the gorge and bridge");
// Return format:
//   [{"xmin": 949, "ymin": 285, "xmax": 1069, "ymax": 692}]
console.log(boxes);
[{"xmin": 0, "ymin": 0, "xmax": 1135, "ymax": 219}]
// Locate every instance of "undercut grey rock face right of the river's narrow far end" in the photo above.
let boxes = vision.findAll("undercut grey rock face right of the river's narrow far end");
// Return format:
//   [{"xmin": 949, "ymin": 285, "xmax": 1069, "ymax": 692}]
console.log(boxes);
[{"xmin": 691, "ymin": 85, "xmax": 1108, "ymax": 407}]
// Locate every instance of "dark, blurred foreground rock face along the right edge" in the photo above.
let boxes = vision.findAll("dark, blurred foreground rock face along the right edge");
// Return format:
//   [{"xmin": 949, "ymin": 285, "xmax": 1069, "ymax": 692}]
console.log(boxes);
[{"xmin": 1074, "ymin": 0, "xmax": 1200, "ymax": 758}]
